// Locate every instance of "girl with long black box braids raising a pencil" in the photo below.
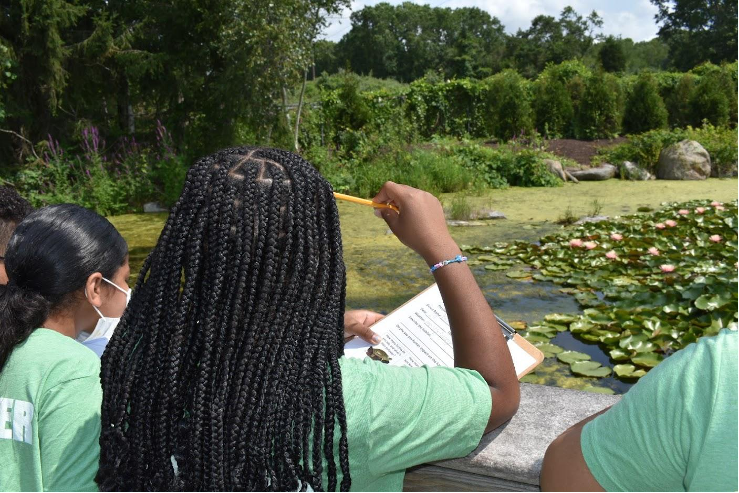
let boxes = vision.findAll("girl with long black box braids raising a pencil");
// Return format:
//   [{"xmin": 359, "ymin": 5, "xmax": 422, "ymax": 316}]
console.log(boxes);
[{"xmin": 97, "ymin": 147, "xmax": 518, "ymax": 491}]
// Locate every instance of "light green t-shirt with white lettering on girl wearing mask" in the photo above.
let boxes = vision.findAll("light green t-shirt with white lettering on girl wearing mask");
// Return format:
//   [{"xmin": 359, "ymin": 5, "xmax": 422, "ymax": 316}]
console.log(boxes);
[{"xmin": 0, "ymin": 329, "xmax": 102, "ymax": 491}]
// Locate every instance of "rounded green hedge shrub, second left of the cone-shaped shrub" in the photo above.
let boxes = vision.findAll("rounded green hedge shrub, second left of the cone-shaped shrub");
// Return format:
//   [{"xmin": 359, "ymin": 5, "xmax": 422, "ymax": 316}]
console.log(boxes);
[{"xmin": 534, "ymin": 78, "xmax": 575, "ymax": 139}]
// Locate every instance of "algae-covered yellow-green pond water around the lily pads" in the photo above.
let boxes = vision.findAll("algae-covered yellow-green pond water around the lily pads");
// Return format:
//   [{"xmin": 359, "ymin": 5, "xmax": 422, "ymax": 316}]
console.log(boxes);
[{"xmin": 111, "ymin": 179, "xmax": 738, "ymax": 393}]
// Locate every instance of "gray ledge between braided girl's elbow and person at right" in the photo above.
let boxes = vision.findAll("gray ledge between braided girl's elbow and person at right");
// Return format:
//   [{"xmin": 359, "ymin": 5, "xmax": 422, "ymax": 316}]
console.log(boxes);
[{"xmin": 405, "ymin": 383, "xmax": 620, "ymax": 491}]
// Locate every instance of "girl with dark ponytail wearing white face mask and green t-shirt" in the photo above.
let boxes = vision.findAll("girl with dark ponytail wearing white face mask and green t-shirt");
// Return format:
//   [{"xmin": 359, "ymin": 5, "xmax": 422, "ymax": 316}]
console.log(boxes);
[{"xmin": 0, "ymin": 205, "xmax": 130, "ymax": 491}]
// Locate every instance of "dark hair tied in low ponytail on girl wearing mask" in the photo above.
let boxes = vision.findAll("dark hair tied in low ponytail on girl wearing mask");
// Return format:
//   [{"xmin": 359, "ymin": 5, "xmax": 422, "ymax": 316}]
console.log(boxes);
[{"xmin": 0, "ymin": 204, "xmax": 128, "ymax": 371}]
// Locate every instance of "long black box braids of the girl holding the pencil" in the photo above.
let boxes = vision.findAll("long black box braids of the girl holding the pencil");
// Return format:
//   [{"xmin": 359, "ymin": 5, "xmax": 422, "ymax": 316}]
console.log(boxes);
[{"xmin": 97, "ymin": 147, "xmax": 351, "ymax": 491}]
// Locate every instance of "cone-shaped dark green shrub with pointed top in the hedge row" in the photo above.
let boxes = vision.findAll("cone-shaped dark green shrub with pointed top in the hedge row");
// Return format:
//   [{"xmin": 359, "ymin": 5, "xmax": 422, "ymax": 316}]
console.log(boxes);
[{"xmin": 623, "ymin": 73, "xmax": 667, "ymax": 134}]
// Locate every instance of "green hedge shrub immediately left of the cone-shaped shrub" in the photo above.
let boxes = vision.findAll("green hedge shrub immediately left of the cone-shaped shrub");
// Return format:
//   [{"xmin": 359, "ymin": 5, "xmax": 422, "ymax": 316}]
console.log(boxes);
[{"xmin": 575, "ymin": 73, "xmax": 621, "ymax": 139}]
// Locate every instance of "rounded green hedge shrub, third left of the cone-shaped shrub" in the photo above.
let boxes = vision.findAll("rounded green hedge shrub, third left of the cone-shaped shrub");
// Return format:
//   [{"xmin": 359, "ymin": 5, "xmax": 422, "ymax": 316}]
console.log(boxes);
[{"xmin": 486, "ymin": 70, "xmax": 533, "ymax": 140}]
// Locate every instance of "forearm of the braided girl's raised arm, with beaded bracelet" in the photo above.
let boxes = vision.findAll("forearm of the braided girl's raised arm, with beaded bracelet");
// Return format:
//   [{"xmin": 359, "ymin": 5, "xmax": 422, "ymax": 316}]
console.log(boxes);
[{"xmin": 424, "ymin": 241, "xmax": 520, "ymax": 431}]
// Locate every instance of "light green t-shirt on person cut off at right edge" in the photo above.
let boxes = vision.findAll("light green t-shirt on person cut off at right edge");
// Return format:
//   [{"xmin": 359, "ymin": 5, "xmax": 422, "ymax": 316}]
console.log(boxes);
[{"xmin": 580, "ymin": 330, "xmax": 737, "ymax": 491}]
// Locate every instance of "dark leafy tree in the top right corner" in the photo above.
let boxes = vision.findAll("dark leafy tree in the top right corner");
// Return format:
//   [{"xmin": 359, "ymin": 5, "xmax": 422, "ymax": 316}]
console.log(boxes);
[{"xmin": 650, "ymin": 0, "xmax": 739, "ymax": 71}]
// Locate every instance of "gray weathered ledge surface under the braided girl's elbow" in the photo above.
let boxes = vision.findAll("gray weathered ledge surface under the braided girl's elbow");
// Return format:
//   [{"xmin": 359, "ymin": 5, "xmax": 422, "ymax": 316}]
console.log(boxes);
[{"xmin": 414, "ymin": 383, "xmax": 620, "ymax": 484}]
